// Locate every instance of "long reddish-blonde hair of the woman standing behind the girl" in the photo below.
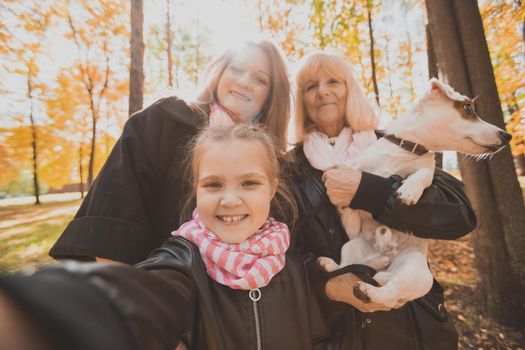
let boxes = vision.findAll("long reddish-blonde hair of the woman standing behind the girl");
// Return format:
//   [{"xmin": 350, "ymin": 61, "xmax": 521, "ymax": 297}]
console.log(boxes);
[{"xmin": 190, "ymin": 40, "xmax": 290, "ymax": 152}]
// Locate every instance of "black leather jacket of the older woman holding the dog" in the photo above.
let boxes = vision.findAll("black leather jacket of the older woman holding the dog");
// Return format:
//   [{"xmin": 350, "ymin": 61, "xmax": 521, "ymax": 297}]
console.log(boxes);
[{"xmin": 288, "ymin": 146, "xmax": 476, "ymax": 350}]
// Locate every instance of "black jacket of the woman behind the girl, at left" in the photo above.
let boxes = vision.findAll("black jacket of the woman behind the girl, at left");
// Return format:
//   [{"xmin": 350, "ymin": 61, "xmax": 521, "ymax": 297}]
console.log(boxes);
[{"xmin": 49, "ymin": 97, "xmax": 205, "ymax": 264}]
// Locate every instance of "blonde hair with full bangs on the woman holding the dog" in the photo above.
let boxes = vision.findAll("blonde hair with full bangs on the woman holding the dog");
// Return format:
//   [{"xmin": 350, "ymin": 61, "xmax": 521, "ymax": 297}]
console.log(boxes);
[{"xmin": 295, "ymin": 52, "xmax": 378, "ymax": 144}]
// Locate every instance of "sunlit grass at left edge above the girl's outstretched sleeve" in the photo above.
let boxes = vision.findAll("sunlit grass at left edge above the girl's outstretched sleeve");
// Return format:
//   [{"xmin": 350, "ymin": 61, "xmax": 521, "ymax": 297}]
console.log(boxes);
[{"xmin": 0, "ymin": 200, "xmax": 80, "ymax": 273}]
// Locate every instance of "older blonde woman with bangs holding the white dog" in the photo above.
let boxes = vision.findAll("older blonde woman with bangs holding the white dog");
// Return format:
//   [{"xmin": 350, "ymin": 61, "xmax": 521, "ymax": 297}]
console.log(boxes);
[{"xmin": 291, "ymin": 53, "xmax": 476, "ymax": 349}]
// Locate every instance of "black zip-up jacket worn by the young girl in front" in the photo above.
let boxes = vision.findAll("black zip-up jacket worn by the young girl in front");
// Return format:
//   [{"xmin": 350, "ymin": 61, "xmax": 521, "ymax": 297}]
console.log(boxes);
[{"xmin": 5, "ymin": 237, "xmax": 328, "ymax": 350}]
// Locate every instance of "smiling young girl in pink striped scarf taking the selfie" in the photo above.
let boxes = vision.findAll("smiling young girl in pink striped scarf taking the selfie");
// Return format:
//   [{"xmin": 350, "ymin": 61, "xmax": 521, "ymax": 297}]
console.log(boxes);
[{"xmin": 0, "ymin": 125, "xmax": 325, "ymax": 350}]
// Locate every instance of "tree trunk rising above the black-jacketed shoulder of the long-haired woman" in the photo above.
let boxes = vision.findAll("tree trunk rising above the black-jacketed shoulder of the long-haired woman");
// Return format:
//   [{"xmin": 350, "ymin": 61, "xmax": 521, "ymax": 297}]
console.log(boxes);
[{"xmin": 129, "ymin": 0, "xmax": 144, "ymax": 116}]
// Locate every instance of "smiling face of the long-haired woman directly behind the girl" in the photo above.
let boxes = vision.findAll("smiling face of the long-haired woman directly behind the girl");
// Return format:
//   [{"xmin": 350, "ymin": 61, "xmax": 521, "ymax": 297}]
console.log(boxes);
[{"xmin": 217, "ymin": 47, "xmax": 271, "ymax": 123}]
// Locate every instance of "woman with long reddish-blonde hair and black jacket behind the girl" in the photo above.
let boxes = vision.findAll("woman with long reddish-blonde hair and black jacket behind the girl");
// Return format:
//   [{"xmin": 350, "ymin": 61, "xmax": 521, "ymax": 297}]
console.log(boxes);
[{"xmin": 50, "ymin": 41, "xmax": 290, "ymax": 264}]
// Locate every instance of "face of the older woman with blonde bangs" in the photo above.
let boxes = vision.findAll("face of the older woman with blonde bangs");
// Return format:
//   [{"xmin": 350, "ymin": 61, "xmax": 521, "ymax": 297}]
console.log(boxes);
[{"xmin": 302, "ymin": 70, "xmax": 347, "ymax": 137}]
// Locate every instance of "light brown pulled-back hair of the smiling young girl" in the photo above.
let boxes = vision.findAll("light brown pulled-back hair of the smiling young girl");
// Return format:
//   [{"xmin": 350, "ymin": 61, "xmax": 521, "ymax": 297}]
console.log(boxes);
[{"xmin": 181, "ymin": 124, "xmax": 298, "ymax": 224}]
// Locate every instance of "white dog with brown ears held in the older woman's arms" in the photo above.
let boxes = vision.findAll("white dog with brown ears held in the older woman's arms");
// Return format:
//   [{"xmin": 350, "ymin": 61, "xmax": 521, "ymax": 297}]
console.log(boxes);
[{"xmin": 319, "ymin": 78, "xmax": 508, "ymax": 308}]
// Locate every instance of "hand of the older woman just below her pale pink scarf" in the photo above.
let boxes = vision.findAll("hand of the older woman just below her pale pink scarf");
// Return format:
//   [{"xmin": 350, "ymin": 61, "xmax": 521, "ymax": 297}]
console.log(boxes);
[{"xmin": 323, "ymin": 165, "xmax": 361, "ymax": 207}]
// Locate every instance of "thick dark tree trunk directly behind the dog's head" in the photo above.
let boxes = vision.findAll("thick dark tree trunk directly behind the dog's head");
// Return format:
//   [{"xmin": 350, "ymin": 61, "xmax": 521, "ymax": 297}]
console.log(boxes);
[{"xmin": 426, "ymin": 0, "xmax": 525, "ymax": 326}]
